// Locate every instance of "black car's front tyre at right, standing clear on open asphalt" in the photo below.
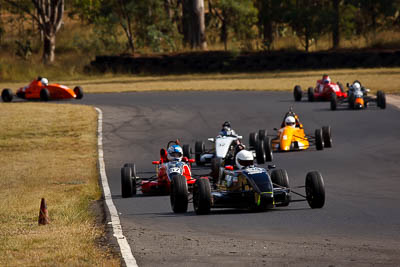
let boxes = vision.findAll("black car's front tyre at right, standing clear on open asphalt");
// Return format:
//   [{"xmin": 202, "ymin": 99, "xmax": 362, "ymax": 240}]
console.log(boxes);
[{"xmin": 306, "ymin": 171, "xmax": 325, "ymax": 209}]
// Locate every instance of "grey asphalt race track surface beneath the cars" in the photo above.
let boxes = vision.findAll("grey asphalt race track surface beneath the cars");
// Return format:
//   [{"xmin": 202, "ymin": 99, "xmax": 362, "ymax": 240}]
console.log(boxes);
[{"xmin": 75, "ymin": 91, "xmax": 400, "ymax": 266}]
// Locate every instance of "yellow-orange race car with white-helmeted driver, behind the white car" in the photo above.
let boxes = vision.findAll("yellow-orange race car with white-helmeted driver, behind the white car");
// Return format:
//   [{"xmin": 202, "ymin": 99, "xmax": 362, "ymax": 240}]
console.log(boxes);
[{"xmin": 249, "ymin": 108, "xmax": 332, "ymax": 155}]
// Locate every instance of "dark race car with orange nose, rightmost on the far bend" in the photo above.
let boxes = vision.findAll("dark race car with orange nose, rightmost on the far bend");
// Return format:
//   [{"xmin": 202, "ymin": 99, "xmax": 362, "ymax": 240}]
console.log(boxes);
[{"xmin": 331, "ymin": 80, "xmax": 386, "ymax": 110}]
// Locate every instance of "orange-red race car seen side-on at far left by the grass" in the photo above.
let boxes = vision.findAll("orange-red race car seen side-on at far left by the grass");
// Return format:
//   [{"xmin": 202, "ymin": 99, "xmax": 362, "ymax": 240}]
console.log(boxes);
[{"xmin": 1, "ymin": 77, "xmax": 83, "ymax": 102}]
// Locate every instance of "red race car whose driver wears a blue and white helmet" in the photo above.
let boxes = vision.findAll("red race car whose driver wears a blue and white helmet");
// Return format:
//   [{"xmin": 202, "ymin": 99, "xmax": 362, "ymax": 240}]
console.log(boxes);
[{"xmin": 121, "ymin": 141, "xmax": 196, "ymax": 212}]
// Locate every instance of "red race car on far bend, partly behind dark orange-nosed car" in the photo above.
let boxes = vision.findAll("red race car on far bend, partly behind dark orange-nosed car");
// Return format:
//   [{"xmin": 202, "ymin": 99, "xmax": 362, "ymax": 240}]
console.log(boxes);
[{"xmin": 293, "ymin": 74, "xmax": 347, "ymax": 102}]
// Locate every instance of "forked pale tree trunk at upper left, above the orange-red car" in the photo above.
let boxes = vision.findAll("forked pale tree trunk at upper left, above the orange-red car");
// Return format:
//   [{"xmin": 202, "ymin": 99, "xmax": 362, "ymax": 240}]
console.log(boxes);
[{"xmin": 4, "ymin": 0, "xmax": 64, "ymax": 64}]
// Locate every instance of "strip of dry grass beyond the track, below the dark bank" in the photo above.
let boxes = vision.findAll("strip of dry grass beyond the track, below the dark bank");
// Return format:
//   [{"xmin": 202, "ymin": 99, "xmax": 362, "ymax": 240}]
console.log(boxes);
[{"xmin": 0, "ymin": 68, "xmax": 400, "ymax": 93}]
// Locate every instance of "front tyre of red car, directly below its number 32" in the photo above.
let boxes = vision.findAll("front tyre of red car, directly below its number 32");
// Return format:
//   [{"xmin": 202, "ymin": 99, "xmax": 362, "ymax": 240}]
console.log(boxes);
[{"xmin": 170, "ymin": 174, "xmax": 189, "ymax": 213}]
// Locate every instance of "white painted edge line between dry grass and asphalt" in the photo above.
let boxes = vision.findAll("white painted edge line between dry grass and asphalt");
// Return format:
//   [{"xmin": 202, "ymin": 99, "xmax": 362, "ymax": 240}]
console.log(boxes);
[{"xmin": 95, "ymin": 107, "xmax": 138, "ymax": 267}]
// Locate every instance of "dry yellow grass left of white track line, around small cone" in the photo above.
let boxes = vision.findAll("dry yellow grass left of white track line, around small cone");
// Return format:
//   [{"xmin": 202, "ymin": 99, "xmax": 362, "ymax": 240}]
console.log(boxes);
[{"xmin": 0, "ymin": 102, "xmax": 119, "ymax": 266}]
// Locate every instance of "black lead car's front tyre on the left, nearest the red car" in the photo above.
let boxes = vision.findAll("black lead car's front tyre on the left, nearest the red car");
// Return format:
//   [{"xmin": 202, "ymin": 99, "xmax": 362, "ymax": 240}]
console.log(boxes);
[{"xmin": 193, "ymin": 178, "xmax": 211, "ymax": 215}]
